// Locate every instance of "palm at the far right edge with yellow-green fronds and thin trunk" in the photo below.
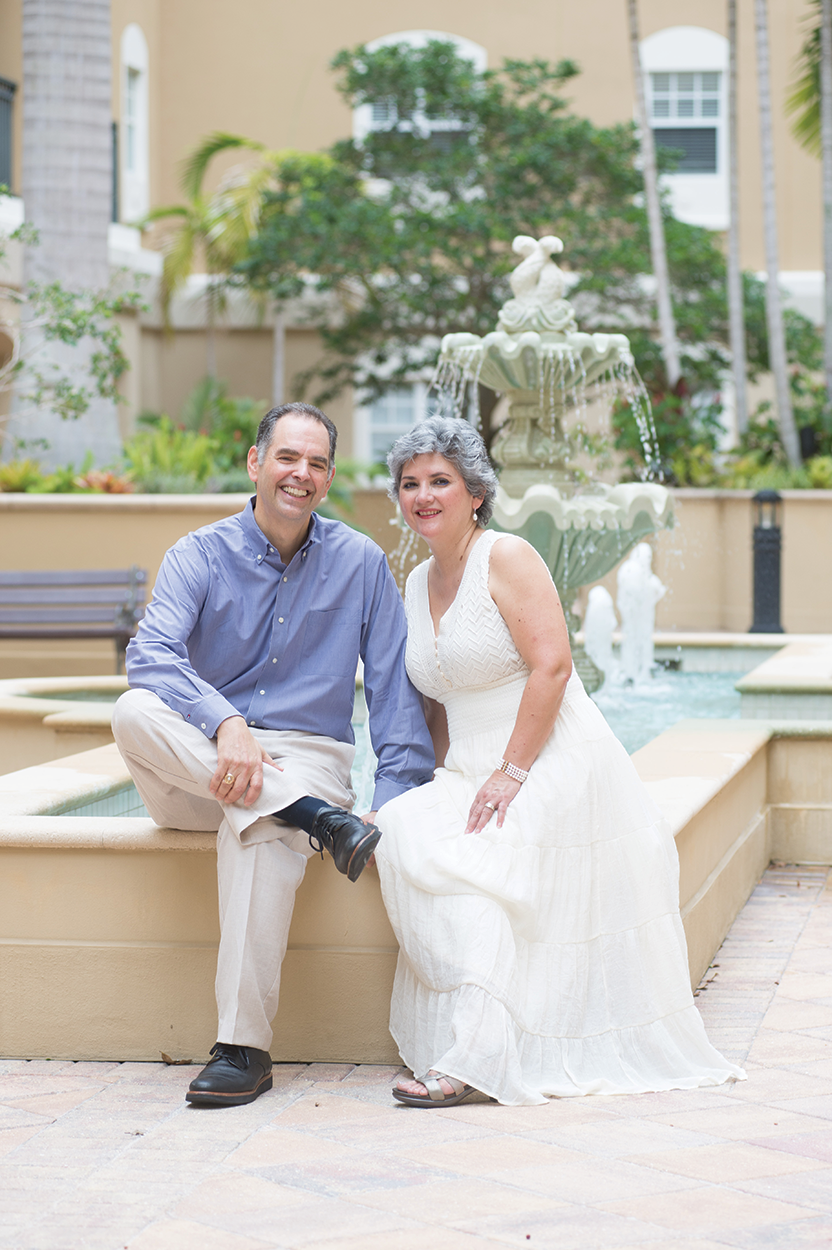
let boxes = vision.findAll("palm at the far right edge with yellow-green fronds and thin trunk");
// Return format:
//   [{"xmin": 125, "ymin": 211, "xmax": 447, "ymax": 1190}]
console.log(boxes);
[{"xmin": 786, "ymin": 0, "xmax": 832, "ymax": 415}]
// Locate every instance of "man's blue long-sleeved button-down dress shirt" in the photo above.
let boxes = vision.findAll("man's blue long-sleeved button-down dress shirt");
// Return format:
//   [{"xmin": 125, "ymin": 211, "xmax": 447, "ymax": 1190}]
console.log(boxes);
[{"xmin": 127, "ymin": 500, "xmax": 433, "ymax": 809}]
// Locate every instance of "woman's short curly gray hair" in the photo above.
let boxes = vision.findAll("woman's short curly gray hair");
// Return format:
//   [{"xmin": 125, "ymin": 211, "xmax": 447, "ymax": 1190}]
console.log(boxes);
[{"xmin": 387, "ymin": 416, "xmax": 497, "ymax": 529}]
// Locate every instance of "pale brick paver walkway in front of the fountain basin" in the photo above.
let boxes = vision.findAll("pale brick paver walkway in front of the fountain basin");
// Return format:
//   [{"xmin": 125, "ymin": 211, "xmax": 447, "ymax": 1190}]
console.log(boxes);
[{"xmin": 0, "ymin": 868, "xmax": 832, "ymax": 1250}]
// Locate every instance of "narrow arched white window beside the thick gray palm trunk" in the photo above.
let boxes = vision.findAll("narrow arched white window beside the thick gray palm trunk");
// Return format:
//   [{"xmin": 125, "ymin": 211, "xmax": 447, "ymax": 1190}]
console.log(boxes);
[{"xmin": 119, "ymin": 23, "xmax": 150, "ymax": 223}]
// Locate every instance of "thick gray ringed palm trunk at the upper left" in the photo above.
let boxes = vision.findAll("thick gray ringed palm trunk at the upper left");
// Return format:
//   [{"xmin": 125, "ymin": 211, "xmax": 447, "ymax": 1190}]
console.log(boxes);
[{"xmin": 9, "ymin": 0, "xmax": 121, "ymax": 465}]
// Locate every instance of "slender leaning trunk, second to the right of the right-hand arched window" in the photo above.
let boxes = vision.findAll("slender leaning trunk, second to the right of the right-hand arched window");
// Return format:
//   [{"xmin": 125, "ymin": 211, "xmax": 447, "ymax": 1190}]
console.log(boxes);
[{"xmin": 755, "ymin": 0, "xmax": 801, "ymax": 466}]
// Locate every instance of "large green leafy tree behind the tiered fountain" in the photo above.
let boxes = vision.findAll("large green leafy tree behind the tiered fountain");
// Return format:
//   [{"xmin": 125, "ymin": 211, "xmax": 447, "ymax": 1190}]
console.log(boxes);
[{"xmin": 240, "ymin": 40, "xmax": 814, "ymax": 465}]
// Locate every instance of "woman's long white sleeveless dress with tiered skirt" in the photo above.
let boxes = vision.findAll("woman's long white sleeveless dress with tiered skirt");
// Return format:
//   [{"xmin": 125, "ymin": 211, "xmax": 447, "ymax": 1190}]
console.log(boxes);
[{"xmin": 376, "ymin": 531, "xmax": 745, "ymax": 1105}]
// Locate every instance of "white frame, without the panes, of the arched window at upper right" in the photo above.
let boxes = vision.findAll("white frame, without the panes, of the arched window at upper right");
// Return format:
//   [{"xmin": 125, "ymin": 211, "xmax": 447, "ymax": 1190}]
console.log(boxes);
[{"xmin": 641, "ymin": 26, "xmax": 730, "ymax": 230}]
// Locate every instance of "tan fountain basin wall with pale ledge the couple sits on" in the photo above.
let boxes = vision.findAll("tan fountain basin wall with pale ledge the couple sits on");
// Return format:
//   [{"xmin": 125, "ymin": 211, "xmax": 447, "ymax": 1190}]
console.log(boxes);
[{"xmin": 0, "ymin": 721, "xmax": 832, "ymax": 1064}]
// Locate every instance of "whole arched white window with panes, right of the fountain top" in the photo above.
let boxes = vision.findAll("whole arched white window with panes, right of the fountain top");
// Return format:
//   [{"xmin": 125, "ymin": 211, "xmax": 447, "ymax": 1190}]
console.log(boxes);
[{"xmin": 641, "ymin": 26, "xmax": 728, "ymax": 230}]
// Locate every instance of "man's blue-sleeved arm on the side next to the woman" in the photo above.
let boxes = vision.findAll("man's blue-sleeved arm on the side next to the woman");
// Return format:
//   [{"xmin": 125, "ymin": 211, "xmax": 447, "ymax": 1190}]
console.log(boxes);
[{"xmin": 361, "ymin": 551, "xmax": 435, "ymax": 810}]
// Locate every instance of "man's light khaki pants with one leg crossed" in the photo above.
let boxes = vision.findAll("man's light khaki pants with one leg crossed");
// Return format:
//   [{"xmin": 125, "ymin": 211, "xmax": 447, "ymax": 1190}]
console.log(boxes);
[{"xmin": 112, "ymin": 690, "xmax": 355, "ymax": 1050}]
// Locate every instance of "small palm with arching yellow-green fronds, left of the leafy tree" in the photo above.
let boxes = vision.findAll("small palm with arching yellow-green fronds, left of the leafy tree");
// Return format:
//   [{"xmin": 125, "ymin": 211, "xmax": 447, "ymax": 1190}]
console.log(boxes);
[{"xmin": 139, "ymin": 131, "xmax": 274, "ymax": 378}]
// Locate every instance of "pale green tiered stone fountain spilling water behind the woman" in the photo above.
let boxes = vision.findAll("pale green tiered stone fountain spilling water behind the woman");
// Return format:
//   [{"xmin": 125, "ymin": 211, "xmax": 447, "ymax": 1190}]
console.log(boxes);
[{"xmin": 436, "ymin": 235, "xmax": 672, "ymax": 690}]
